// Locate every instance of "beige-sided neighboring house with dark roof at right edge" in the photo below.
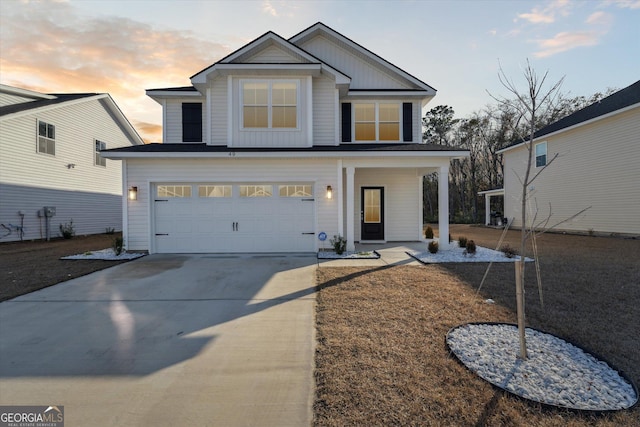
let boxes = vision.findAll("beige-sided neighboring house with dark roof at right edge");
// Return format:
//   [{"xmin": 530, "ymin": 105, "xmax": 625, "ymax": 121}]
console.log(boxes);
[{"xmin": 500, "ymin": 81, "xmax": 640, "ymax": 235}]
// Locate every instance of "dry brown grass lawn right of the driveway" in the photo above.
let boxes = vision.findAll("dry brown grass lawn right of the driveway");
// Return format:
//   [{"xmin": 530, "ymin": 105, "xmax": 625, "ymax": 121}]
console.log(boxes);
[{"xmin": 314, "ymin": 226, "xmax": 640, "ymax": 426}]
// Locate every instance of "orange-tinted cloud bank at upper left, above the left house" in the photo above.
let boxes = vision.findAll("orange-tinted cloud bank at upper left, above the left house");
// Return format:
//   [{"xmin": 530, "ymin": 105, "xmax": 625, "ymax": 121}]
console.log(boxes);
[{"xmin": 0, "ymin": 2, "xmax": 230, "ymax": 141}]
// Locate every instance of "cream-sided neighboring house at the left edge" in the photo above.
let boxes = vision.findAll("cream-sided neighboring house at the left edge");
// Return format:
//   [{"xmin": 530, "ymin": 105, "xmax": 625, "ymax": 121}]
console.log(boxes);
[{"xmin": 0, "ymin": 85, "xmax": 143, "ymax": 242}]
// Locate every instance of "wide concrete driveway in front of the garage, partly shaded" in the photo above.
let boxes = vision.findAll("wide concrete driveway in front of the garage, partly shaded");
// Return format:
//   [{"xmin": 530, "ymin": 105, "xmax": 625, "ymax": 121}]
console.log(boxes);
[{"xmin": 0, "ymin": 255, "xmax": 317, "ymax": 426}]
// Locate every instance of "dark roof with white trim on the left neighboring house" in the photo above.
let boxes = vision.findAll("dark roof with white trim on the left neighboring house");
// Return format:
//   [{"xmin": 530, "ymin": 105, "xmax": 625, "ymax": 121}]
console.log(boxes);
[{"xmin": 0, "ymin": 86, "xmax": 144, "ymax": 145}]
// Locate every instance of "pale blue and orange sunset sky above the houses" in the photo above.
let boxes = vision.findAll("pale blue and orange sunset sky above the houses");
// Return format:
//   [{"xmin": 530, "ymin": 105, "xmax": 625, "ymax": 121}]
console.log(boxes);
[{"xmin": 0, "ymin": 0, "xmax": 640, "ymax": 142}]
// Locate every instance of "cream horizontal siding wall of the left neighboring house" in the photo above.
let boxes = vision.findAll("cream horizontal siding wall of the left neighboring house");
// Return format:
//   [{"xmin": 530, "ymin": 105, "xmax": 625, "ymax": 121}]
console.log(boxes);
[{"xmin": 0, "ymin": 100, "xmax": 131, "ymax": 241}]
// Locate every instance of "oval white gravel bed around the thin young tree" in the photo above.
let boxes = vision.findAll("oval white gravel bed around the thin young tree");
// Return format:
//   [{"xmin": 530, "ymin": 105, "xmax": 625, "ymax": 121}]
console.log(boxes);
[{"xmin": 446, "ymin": 324, "xmax": 638, "ymax": 411}]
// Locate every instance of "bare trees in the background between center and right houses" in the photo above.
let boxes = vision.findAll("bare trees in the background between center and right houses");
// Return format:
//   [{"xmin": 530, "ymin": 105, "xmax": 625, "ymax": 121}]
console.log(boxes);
[{"xmin": 422, "ymin": 88, "xmax": 616, "ymax": 223}]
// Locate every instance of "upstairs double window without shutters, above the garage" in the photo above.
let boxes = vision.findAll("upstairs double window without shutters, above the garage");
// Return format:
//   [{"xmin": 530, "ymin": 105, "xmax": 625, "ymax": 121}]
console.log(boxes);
[{"xmin": 241, "ymin": 80, "xmax": 298, "ymax": 129}]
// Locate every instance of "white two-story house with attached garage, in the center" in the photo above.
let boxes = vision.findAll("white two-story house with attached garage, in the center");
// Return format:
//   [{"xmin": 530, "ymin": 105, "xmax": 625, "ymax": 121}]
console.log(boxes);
[{"xmin": 104, "ymin": 23, "xmax": 468, "ymax": 253}]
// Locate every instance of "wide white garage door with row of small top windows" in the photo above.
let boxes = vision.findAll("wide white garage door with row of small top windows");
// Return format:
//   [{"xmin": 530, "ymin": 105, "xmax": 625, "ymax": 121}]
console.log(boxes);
[{"xmin": 153, "ymin": 183, "xmax": 315, "ymax": 253}]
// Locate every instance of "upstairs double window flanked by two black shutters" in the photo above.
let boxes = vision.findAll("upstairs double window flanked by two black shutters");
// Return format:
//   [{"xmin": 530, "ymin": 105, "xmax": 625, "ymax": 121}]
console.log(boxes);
[{"xmin": 354, "ymin": 102, "xmax": 400, "ymax": 141}]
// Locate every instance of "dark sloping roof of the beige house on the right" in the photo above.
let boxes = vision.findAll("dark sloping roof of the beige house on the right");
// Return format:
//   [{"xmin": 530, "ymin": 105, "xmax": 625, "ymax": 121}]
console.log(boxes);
[{"xmin": 499, "ymin": 80, "xmax": 640, "ymax": 153}]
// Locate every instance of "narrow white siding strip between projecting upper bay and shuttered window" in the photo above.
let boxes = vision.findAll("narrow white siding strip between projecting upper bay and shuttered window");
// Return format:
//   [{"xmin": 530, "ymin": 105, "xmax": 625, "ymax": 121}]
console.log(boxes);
[{"xmin": 313, "ymin": 78, "xmax": 338, "ymax": 145}]
